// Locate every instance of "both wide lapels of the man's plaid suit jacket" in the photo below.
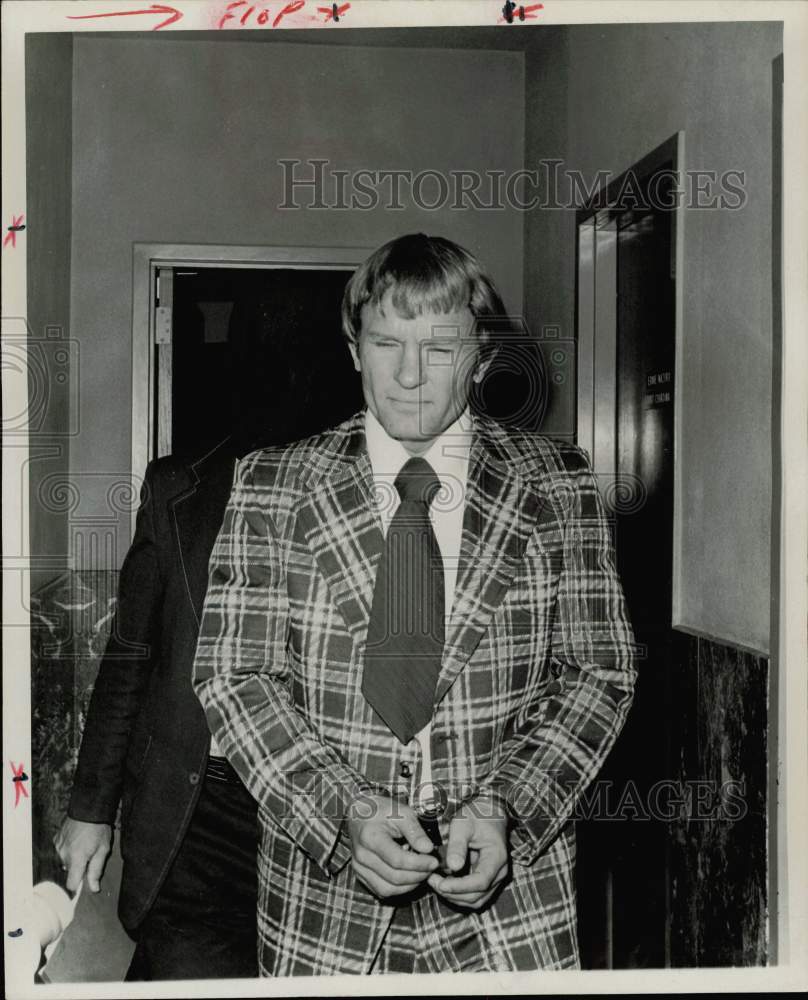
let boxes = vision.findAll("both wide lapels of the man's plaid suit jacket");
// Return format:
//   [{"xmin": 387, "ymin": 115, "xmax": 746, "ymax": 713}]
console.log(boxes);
[{"xmin": 295, "ymin": 412, "xmax": 557, "ymax": 688}]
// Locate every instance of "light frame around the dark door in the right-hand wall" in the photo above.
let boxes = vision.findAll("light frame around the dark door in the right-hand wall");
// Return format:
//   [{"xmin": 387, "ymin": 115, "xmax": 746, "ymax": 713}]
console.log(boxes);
[{"xmin": 575, "ymin": 131, "xmax": 686, "ymax": 628}]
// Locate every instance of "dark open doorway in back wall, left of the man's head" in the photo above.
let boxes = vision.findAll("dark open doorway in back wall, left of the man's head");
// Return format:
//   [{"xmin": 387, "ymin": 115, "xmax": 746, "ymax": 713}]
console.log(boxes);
[{"xmin": 163, "ymin": 267, "xmax": 362, "ymax": 460}]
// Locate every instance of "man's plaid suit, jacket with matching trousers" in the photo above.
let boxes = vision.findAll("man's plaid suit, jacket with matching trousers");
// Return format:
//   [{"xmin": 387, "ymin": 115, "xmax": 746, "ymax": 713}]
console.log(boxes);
[{"xmin": 194, "ymin": 413, "xmax": 635, "ymax": 975}]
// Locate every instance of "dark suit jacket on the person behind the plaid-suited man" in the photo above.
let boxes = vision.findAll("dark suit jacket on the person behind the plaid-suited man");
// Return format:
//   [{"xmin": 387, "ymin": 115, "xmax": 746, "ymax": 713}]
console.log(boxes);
[{"xmin": 68, "ymin": 442, "xmax": 235, "ymax": 931}]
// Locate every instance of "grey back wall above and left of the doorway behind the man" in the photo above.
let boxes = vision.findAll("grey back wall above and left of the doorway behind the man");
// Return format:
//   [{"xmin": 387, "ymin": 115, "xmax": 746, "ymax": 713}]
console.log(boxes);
[{"xmin": 71, "ymin": 35, "xmax": 524, "ymax": 565}]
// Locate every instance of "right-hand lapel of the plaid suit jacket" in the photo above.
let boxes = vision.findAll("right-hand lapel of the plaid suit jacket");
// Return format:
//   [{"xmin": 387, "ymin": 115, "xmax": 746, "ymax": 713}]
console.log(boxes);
[{"xmin": 435, "ymin": 421, "xmax": 556, "ymax": 704}]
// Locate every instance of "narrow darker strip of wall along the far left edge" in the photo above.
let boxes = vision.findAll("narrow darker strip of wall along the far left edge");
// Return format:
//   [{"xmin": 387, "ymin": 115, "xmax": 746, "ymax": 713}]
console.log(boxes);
[{"xmin": 25, "ymin": 33, "xmax": 74, "ymax": 590}]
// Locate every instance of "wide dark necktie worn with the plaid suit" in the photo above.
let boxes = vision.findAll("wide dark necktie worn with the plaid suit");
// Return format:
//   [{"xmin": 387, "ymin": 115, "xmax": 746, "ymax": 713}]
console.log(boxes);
[{"xmin": 362, "ymin": 458, "xmax": 444, "ymax": 743}]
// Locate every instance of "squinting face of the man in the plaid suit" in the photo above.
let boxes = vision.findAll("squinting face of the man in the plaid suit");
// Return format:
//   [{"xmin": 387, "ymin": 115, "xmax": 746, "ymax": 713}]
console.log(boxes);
[{"xmin": 350, "ymin": 291, "xmax": 477, "ymax": 455}]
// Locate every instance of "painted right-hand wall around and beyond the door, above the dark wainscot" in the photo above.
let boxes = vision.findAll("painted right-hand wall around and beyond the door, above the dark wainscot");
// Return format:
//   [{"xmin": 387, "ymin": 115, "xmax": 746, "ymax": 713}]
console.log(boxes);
[{"xmin": 525, "ymin": 23, "xmax": 782, "ymax": 652}]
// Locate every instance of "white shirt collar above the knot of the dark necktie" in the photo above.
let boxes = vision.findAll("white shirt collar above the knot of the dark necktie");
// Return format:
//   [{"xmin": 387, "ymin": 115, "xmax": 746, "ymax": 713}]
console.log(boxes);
[{"xmin": 365, "ymin": 409, "xmax": 471, "ymax": 485}]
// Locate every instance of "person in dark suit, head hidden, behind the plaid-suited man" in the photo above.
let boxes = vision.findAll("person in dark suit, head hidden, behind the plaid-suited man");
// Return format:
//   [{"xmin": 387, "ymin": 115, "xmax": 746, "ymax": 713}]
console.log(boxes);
[{"xmin": 56, "ymin": 441, "xmax": 257, "ymax": 980}]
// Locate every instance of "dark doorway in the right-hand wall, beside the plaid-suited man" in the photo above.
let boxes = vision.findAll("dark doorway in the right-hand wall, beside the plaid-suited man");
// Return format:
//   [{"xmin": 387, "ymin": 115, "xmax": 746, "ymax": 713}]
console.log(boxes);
[{"xmin": 577, "ymin": 135, "xmax": 682, "ymax": 968}]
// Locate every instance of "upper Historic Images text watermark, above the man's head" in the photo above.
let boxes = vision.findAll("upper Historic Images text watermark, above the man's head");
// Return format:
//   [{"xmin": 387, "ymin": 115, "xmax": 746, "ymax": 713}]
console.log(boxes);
[{"xmin": 277, "ymin": 159, "xmax": 747, "ymax": 212}]
